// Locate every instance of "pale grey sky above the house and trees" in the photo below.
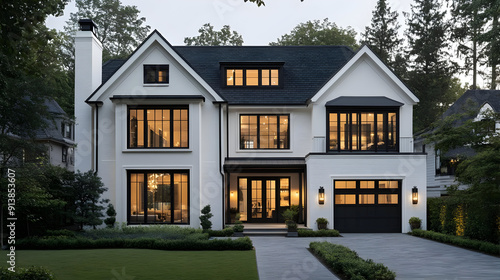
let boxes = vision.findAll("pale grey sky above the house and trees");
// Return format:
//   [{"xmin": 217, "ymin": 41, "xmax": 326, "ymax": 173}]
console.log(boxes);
[{"xmin": 46, "ymin": 0, "xmax": 412, "ymax": 46}]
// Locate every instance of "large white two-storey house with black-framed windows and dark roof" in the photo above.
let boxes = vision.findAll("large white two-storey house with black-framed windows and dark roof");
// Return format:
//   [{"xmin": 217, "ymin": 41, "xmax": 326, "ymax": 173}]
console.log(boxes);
[{"xmin": 75, "ymin": 20, "xmax": 426, "ymax": 232}]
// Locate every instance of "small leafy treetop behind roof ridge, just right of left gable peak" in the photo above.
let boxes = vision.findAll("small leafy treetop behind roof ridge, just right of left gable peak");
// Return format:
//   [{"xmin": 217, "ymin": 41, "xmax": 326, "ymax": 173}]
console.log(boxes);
[{"xmin": 184, "ymin": 23, "xmax": 243, "ymax": 46}]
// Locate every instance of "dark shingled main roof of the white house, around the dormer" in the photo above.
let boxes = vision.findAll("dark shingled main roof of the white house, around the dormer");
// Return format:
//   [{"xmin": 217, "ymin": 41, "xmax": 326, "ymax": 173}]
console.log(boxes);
[{"xmin": 102, "ymin": 46, "xmax": 354, "ymax": 105}]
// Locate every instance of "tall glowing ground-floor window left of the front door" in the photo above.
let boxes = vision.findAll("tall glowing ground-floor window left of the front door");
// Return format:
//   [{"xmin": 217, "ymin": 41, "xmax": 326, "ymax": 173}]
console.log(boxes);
[{"xmin": 128, "ymin": 170, "xmax": 189, "ymax": 224}]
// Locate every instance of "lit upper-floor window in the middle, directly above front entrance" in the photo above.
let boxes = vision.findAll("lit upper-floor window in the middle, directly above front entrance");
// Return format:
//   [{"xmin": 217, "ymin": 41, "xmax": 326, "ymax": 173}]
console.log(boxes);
[{"xmin": 240, "ymin": 115, "xmax": 290, "ymax": 149}]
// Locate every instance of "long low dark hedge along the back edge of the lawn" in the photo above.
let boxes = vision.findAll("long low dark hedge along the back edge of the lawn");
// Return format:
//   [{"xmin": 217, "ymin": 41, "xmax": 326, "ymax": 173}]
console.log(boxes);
[{"xmin": 16, "ymin": 237, "xmax": 253, "ymax": 251}]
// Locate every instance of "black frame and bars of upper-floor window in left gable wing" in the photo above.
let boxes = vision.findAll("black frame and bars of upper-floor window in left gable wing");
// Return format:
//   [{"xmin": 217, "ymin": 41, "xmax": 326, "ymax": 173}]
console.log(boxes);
[{"xmin": 127, "ymin": 105, "xmax": 190, "ymax": 149}]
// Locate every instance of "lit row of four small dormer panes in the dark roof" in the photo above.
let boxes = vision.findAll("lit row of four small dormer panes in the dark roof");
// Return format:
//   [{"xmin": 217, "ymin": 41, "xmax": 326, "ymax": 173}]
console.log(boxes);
[{"xmin": 224, "ymin": 67, "xmax": 281, "ymax": 87}]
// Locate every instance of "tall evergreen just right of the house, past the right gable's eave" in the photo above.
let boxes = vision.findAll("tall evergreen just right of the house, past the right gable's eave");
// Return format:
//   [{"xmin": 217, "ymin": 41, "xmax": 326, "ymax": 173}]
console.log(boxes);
[{"xmin": 405, "ymin": 0, "xmax": 456, "ymax": 131}]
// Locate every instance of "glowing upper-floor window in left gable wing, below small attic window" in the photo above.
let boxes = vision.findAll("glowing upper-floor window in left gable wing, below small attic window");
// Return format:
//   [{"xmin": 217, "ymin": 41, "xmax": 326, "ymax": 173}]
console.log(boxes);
[{"xmin": 128, "ymin": 106, "xmax": 189, "ymax": 149}]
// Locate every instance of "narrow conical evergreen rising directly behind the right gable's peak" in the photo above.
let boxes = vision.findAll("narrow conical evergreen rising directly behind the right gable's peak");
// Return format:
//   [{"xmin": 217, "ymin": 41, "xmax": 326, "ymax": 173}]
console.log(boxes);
[{"xmin": 362, "ymin": 0, "xmax": 403, "ymax": 69}]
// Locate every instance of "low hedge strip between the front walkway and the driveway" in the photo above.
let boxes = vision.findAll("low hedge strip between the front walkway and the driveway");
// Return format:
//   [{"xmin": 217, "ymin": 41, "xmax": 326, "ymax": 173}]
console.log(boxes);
[{"xmin": 309, "ymin": 241, "xmax": 396, "ymax": 280}]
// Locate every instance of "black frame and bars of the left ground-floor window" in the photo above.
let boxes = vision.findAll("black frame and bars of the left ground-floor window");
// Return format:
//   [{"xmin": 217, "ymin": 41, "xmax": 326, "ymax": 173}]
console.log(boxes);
[{"xmin": 127, "ymin": 169, "xmax": 191, "ymax": 225}]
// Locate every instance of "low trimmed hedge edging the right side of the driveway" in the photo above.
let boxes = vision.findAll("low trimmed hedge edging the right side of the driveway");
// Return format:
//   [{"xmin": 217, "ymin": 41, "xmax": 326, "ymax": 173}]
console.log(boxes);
[{"xmin": 409, "ymin": 229, "xmax": 500, "ymax": 256}]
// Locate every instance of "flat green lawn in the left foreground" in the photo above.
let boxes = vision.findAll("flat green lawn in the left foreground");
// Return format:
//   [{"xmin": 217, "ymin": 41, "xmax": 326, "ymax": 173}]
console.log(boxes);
[{"xmin": 2, "ymin": 249, "xmax": 258, "ymax": 280}]
